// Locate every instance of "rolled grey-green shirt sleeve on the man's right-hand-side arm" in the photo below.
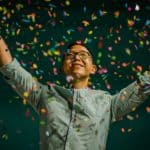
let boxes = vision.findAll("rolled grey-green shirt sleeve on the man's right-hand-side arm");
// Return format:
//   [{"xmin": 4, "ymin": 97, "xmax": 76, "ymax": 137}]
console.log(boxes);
[{"xmin": 111, "ymin": 74, "xmax": 150, "ymax": 122}]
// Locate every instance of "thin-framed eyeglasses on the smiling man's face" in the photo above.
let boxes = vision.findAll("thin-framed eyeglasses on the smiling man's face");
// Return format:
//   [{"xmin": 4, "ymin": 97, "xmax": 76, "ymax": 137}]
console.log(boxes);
[{"xmin": 65, "ymin": 51, "xmax": 92, "ymax": 60}]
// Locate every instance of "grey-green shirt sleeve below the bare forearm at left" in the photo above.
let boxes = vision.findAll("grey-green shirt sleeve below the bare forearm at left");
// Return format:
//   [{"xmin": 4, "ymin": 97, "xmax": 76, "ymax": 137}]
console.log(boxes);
[{"xmin": 0, "ymin": 58, "xmax": 44, "ymax": 111}]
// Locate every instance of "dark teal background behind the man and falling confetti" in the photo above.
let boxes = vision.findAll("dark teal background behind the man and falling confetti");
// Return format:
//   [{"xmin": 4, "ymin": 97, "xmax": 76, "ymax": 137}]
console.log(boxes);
[{"xmin": 0, "ymin": 0, "xmax": 150, "ymax": 150}]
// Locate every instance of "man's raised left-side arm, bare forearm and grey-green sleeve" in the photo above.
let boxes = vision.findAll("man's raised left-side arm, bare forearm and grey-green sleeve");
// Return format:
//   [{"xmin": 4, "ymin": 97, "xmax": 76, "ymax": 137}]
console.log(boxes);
[{"xmin": 0, "ymin": 38, "xmax": 46, "ymax": 111}]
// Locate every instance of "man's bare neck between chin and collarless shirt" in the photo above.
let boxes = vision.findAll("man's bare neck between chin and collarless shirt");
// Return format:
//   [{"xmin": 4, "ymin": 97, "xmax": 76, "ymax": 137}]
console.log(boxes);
[{"xmin": 72, "ymin": 78, "xmax": 88, "ymax": 89}]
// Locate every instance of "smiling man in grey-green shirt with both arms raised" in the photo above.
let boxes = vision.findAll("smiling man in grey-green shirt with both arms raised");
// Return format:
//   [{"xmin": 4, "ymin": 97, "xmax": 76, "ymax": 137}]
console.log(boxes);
[{"xmin": 0, "ymin": 35, "xmax": 150, "ymax": 150}]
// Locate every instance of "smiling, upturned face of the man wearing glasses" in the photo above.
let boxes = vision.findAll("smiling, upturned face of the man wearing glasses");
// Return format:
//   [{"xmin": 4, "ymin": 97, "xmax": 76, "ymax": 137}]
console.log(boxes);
[{"xmin": 63, "ymin": 45, "xmax": 96, "ymax": 79}]
